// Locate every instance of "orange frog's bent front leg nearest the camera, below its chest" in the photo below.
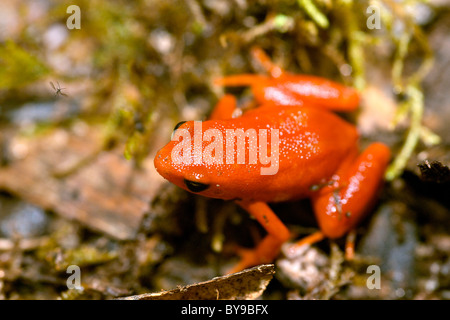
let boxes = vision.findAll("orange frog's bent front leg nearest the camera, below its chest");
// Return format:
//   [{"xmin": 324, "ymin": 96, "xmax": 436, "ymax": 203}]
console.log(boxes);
[{"xmin": 229, "ymin": 201, "xmax": 290, "ymax": 273}]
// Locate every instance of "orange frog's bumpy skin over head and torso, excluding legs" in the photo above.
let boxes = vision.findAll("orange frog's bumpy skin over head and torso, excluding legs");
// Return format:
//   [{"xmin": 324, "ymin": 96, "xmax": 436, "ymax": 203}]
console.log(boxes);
[{"xmin": 155, "ymin": 106, "xmax": 358, "ymax": 202}]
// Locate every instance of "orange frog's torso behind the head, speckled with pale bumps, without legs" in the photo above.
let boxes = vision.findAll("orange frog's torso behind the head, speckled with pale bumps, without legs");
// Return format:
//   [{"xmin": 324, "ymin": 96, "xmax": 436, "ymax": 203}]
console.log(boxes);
[{"xmin": 227, "ymin": 106, "xmax": 358, "ymax": 202}]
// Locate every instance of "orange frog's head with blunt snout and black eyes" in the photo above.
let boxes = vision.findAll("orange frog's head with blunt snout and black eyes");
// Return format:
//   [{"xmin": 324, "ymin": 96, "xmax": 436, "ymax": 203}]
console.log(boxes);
[{"xmin": 154, "ymin": 120, "xmax": 248, "ymax": 200}]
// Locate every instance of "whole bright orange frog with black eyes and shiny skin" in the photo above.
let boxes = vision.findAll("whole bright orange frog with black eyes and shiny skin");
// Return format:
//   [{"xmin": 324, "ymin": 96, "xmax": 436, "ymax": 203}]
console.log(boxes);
[{"xmin": 155, "ymin": 48, "xmax": 390, "ymax": 272}]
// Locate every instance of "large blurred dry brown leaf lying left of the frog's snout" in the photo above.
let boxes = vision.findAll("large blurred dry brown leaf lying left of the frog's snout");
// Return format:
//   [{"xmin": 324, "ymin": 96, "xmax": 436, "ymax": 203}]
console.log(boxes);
[{"xmin": 0, "ymin": 126, "xmax": 164, "ymax": 240}]
